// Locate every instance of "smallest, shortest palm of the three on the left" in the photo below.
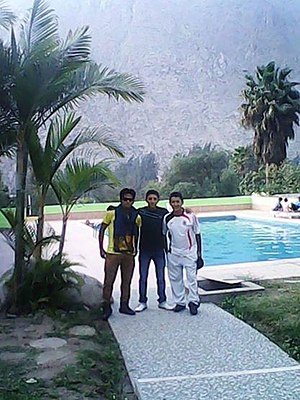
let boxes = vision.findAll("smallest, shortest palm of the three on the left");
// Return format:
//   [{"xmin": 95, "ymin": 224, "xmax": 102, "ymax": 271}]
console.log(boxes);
[{"xmin": 52, "ymin": 159, "xmax": 118, "ymax": 255}]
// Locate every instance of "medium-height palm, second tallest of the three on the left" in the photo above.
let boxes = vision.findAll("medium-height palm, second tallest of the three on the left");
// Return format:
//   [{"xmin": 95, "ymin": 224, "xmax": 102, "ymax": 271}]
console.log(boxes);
[{"xmin": 28, "ymin": 112, "xmax": 123, "ymax": 258}]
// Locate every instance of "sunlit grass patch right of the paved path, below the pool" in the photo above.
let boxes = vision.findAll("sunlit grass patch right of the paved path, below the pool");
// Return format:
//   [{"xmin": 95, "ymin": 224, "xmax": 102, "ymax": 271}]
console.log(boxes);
[{"xmin": 222, "ymin": 281, "xmax": 300, "ymax": 361}]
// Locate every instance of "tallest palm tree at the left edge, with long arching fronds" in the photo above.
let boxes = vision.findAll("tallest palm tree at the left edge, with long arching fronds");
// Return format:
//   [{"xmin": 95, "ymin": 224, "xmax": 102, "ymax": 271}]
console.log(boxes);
[{"xmin": 0, "ymin": 0, "xmax": 143, "ymax": 306}]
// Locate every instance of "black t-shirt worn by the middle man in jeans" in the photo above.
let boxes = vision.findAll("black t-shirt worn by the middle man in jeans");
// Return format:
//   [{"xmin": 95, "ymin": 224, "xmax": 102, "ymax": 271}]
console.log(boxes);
[{"xmin": 138, "ymin": 207, "xmax": 168, "ymax": 251}]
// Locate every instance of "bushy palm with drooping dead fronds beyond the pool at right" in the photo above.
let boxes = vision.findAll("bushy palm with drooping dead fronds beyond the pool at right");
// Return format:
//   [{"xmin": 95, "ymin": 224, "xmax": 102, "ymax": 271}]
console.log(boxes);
[{"xmin": 241, "ymin": 61, "xmax": 300, "ymax": 184}]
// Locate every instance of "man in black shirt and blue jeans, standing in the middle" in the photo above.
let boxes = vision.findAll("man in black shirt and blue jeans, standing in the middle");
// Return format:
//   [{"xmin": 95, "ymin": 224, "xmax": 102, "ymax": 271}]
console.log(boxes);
[{"xmin": 135, "ymin": 190, "xmax": 173, "ymax": 312}]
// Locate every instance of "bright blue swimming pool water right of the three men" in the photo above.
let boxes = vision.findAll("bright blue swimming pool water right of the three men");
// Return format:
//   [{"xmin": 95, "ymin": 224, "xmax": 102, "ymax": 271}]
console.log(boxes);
[{"xmin": 199, "ymin": 216, "xmax": 300, "ymax": 265}]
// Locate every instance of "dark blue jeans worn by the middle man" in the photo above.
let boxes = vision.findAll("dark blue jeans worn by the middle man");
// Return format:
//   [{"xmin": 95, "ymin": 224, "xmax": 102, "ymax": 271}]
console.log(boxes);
[{"xmin": 139, "ymin": 250, "xmax": 166, "ymax": 303}]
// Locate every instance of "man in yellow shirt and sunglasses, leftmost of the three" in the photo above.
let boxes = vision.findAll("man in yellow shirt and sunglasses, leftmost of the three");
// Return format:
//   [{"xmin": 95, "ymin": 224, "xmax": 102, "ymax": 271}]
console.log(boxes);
[{"xmin": 99, "ymin": 188, "xmax": 141, "ymax": 321}]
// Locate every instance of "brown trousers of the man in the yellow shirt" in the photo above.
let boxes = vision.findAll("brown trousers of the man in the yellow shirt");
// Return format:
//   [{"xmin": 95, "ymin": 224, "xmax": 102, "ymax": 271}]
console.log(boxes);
[{"xmin": 102, "ymin": 254, "xmax": 134, "ymax": 303}]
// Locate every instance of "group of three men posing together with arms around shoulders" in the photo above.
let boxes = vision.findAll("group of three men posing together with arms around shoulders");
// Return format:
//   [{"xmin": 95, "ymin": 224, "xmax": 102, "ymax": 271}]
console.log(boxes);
[{"xmin": 99, "ymin": 188, "xmax": 203, "ymax": 320}]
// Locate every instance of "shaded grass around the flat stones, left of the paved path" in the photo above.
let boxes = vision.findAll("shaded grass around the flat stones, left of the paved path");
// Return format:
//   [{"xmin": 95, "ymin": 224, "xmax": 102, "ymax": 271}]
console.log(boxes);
[{"xmin": 0, "ymin": 310, "xmax": 136, "ymax": 400}]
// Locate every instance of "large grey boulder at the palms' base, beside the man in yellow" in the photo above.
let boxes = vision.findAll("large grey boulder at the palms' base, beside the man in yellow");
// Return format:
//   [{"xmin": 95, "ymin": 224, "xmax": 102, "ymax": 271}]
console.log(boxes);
[{"xmin": 67, "ymin": 273, "xmax": 102, "ymax": 309}]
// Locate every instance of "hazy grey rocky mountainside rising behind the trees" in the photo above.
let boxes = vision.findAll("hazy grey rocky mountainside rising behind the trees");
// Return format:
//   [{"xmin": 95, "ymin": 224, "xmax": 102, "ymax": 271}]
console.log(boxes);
[{"xmin": 1, "ymin": 0, "xmax": 300, "ymax": 185}]
